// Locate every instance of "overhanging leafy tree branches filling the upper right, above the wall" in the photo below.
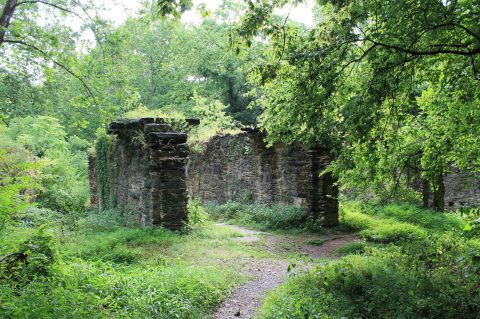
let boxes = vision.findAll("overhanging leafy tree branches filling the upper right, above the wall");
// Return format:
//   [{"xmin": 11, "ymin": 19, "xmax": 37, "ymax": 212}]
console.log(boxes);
[{"xmin": 240, "ymin": 0, "xmax": 480, "ymax": 202}]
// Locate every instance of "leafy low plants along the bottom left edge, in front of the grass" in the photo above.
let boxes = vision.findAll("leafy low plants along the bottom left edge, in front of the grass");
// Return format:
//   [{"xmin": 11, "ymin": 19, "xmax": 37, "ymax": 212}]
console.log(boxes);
[{"xmin": 0, "ymin": 259, "xmax": 231, "ymax": 319}]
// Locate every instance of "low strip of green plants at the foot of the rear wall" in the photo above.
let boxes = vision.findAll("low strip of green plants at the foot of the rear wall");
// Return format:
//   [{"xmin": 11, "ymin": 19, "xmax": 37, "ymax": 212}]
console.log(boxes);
[{"xmin": 206, "ymin": 201, "xmax": 314, "ymax": 230}]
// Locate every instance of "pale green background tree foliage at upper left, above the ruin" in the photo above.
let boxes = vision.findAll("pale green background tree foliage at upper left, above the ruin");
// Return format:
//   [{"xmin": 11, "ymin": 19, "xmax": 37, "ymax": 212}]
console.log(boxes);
[{"xmin": 0, "ymin": 0, "xmax": 261, "ymax": 140}]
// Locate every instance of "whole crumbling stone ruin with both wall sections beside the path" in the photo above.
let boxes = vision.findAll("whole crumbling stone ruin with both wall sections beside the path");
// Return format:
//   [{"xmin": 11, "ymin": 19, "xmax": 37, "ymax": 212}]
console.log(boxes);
[{"xmin": 90, "ymin": 118, "xmax": 338, "ymax": 229}]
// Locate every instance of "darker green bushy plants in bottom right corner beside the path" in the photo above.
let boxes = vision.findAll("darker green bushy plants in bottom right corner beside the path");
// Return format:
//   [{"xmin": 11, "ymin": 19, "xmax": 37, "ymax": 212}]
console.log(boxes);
[{"xmin": 259, "ymin": 241, "xmax": 480, "ymax": 319}]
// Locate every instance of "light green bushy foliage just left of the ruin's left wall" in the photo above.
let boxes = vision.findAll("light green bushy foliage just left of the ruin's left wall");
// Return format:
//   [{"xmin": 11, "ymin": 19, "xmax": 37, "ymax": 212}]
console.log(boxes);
[{"xmin": 6, "ymin": 116, "xmax": 89, "ymax": 214}]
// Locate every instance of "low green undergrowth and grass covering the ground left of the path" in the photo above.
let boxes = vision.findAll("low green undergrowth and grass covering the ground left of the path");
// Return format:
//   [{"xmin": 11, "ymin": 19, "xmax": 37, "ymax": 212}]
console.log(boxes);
[{"xmin": 0, "ymin": 208, "xmax": 255, "ymax": 319}]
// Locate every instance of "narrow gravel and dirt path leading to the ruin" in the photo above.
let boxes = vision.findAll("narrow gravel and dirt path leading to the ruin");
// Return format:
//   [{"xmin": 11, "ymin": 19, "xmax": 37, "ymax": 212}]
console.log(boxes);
[{"xmin": 212, "ymin": 224, "xmax": 356, "ymax": 319}]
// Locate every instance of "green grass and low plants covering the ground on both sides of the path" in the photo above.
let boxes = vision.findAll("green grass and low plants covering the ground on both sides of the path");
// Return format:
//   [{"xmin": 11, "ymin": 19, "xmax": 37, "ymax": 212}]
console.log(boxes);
[{"xmin": 4, "ymin": 202, "xmax": 480, "ymax": 319}]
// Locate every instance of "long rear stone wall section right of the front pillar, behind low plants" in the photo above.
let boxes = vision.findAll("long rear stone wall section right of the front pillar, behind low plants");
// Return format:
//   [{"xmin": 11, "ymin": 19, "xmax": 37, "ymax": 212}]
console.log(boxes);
[{"xmin": 187, "ymin": 132, "xmax": 338, "ymax": 226}]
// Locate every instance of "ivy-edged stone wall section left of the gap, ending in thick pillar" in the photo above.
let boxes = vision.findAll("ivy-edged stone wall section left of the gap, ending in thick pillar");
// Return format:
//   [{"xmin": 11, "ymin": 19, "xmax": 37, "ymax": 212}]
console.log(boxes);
[{"xmin": 90, "ymin": 118, "xmax": 196, "ymax": 229}]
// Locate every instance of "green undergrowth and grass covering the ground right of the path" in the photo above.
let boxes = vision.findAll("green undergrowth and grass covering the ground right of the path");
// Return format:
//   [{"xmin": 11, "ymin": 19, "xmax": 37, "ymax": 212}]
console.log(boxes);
[{"xmin": 255, "ymin": 202, "xmax": 480, "ymax": 319}]
